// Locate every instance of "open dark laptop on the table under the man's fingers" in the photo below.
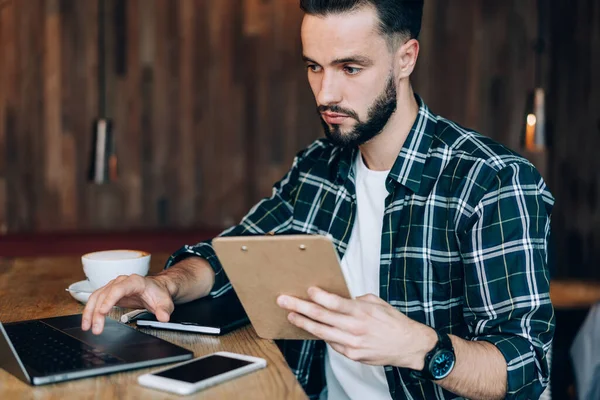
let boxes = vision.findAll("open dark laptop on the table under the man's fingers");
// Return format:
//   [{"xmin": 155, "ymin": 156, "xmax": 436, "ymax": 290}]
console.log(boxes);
[{"xmin": 0, "ymin": 314, "xmax": 194, "ymax": 385}]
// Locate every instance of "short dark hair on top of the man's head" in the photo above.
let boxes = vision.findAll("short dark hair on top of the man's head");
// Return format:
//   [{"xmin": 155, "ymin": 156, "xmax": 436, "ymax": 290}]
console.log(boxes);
[{"xmin": 300, "ymin": 0, "xmax": 424, "ymax": 45}]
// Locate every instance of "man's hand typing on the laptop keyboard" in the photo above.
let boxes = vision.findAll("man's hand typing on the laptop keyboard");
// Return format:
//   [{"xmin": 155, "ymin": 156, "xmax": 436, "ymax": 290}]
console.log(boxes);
[{"xmin": 81, "ymin": 275, "xmax": 175, "ymax": 335}]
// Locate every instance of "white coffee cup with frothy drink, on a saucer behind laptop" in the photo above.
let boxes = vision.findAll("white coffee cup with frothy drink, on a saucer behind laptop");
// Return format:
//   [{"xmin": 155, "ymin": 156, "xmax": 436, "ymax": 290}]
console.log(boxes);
[{"xmin": 81, "ymin": 250, "xmax": 150, "ymax": 290}]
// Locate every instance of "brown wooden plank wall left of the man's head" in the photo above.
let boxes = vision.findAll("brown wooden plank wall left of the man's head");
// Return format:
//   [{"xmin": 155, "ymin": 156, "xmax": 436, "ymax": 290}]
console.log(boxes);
[{"xmin": 0, "ymin": 0, "xmax": 320, "ymax": 232}]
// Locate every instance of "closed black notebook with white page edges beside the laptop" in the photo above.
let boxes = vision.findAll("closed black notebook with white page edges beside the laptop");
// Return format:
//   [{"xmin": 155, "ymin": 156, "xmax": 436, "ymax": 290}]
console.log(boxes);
[{"xmin": 136, "ymin": 290, "xmax": 249, "ymax": 335}]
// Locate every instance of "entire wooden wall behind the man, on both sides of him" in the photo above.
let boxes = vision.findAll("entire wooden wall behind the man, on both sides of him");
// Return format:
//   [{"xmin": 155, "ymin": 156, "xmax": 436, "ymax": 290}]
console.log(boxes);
[{"xmin": 0, "ymin": 0, "xmax": 600, "ymax": 276}]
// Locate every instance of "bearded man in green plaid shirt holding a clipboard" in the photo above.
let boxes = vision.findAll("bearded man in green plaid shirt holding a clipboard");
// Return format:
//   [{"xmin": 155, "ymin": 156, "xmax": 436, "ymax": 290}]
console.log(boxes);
[{"xmin": 83, "ymin": 0, "xmax": 554, "ymax": 399}]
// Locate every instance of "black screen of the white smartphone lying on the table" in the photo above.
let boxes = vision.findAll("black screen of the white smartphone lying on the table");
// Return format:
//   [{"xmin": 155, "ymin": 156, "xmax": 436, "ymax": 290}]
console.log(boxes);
[{"xmin": 154, "ymin": 355, "xmax": 252, "ymax": 383}]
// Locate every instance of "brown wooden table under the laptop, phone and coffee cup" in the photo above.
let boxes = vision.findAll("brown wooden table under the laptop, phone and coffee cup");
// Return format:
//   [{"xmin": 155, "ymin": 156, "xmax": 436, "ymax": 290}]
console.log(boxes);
[{"xmin": 0, "ymin": 255, "xmax": 306, "ymax": 399}]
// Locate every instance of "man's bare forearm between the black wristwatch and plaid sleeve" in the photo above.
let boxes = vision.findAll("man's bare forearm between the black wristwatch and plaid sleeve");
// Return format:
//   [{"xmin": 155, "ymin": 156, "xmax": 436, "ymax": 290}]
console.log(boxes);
[{"xmin": 436, "ymin": 335, "xmax": 507, "ymax": 400}]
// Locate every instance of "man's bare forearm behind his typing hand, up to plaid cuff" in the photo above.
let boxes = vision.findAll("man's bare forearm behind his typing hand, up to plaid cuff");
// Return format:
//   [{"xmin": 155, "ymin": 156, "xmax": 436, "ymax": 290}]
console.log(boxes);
[{"xmin": 154, "ymin": 257, "xmax": 215, "ymax": 304}]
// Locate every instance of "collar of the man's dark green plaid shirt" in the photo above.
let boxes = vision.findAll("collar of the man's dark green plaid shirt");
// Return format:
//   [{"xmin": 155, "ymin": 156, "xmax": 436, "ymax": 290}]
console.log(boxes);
[{"xmin": 334, "ymin": 94, "xmax": 437, "ymax": 193}]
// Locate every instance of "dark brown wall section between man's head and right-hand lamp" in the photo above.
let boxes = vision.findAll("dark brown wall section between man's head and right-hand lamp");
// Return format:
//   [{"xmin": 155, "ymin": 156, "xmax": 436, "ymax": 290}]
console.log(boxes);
[{"xmin": 414, "ymin": 0, "xmax": 537, "ymax": 150}]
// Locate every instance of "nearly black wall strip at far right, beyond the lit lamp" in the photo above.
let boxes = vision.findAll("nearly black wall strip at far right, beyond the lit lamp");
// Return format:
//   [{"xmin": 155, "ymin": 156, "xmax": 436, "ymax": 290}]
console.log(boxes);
[{"xmin": 549, "ymin": 0, "xmax": 600, "ymax": 280}]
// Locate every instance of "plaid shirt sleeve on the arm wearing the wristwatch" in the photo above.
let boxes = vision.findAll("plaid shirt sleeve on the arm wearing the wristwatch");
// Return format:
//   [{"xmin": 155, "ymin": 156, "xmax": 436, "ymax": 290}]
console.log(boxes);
[{"xmin": 461, "ymin": 163, "xmax": 554, "ymax": 399}]
